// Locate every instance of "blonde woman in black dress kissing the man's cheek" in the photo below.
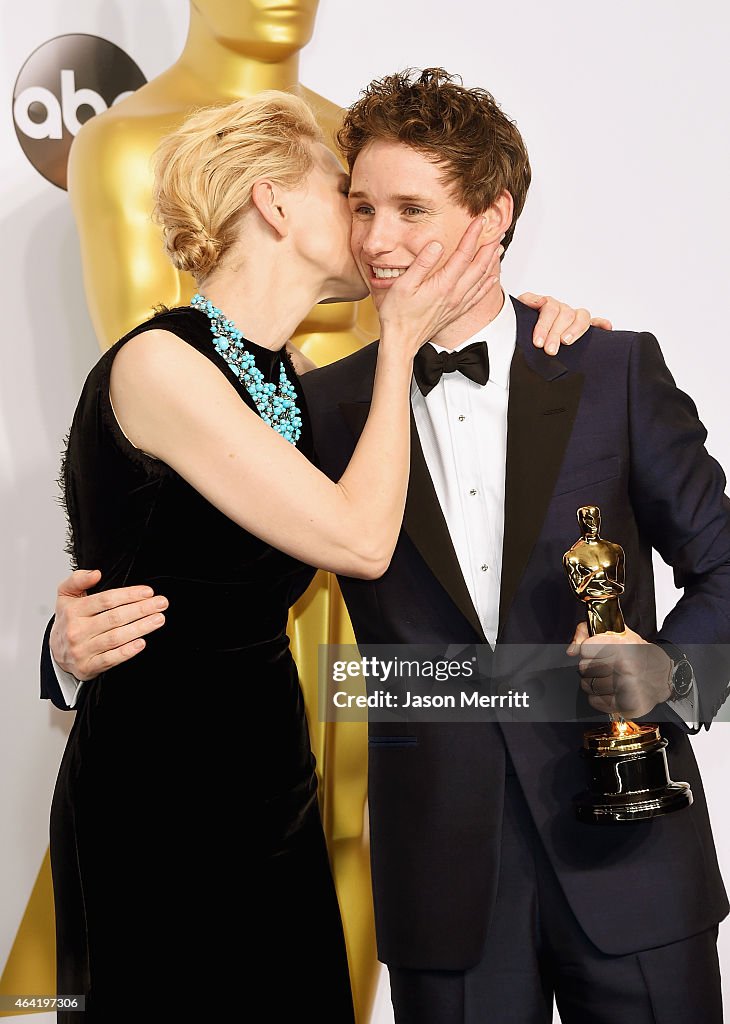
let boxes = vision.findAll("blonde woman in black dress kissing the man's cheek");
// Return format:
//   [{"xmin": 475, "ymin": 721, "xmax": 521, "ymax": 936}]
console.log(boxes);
[{"xmin": 51, "ymin": 92, "xmax": 497, "ymax": 1022}]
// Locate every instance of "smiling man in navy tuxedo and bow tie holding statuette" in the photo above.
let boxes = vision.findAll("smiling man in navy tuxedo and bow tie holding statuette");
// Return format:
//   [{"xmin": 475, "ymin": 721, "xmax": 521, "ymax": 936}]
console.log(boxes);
[{"xmin": 45, "ymin": 70, "xmax": 730, "ymax": 1024}]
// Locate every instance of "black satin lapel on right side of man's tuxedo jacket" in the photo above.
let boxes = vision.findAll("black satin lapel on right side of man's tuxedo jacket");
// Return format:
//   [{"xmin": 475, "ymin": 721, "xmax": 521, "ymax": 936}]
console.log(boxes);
[{"xmin": 500, "ymin": 356, "xmax": 583, "ymax": 632}]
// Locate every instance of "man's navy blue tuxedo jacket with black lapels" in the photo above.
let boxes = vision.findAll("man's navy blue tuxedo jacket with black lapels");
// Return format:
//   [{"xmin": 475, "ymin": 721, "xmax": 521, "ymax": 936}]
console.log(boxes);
[{"xmin": 303, "ymin": 300, "xmax": 730, "ymax": 970}]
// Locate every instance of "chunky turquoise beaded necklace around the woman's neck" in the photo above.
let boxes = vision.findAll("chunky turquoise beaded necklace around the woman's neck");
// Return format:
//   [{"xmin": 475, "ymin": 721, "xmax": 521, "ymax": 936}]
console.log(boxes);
[{"xmin": 190, "ymin": 293, "xmax": 302, "ymax": 444}]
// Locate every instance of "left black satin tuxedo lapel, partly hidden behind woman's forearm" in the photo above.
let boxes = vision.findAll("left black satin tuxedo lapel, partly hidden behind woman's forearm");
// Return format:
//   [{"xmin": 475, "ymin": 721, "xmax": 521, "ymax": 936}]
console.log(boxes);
[{"xmin": 340, "ymin": 401, "xmax": 486, "ymax": 643}]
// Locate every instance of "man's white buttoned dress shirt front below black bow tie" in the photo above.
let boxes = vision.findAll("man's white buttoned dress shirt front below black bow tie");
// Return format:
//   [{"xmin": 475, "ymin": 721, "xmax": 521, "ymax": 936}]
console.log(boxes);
[{"xmin": 411, "ymin": 297, "xmax": 517, "ymax": 647}]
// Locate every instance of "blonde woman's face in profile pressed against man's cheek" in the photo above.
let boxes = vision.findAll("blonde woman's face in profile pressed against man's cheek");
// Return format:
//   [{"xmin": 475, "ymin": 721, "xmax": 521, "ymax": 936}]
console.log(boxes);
[{"xmin": 289, "ymin": 142, "xmax": 369, "ymax": 301}]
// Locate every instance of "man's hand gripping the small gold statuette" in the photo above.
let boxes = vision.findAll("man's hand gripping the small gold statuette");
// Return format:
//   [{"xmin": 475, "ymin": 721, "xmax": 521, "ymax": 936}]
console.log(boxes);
[{"xmin": 567, "ymin": 623, "xmax": 672, "ymax": 719}]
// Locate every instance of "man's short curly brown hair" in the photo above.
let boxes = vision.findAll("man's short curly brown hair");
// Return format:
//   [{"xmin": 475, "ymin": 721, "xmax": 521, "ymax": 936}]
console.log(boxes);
[{"xmin": 337, "ymin": 68, "xmax": 531, "ymax": 250}]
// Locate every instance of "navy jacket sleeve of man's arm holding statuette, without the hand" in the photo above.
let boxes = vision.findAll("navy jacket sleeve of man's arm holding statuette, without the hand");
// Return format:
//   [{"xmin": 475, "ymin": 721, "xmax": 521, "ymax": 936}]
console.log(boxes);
[{"xmin": 629, "ymin": 334, "xmax": 730, "ymax": 726}]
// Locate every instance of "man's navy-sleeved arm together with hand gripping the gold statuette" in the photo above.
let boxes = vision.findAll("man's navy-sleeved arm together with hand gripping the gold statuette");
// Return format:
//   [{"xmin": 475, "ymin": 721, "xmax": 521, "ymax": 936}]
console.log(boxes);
[{"xmin": 577, "ymin": 334, "xmax": 730, "ymax": 727}]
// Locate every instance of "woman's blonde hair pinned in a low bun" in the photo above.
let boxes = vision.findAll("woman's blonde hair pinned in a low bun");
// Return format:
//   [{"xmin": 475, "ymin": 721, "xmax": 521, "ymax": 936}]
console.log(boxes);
[{"xmin": 153, "ymin": 89, "xmax": 323, "ymax": 282}]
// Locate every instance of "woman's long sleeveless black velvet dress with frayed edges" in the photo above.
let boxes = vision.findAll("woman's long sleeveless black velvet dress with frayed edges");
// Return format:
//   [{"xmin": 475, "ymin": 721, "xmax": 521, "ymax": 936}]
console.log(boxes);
[{"xmin": 51, "ymin": 307, "xmax": 352, "ymax": 1024}]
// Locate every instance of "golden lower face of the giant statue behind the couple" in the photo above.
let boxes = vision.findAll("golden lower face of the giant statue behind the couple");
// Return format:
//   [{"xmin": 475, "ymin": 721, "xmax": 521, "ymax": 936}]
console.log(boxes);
[{"xmin": 191, "ymin": 0, "xmax": 318, "ymax": 57}]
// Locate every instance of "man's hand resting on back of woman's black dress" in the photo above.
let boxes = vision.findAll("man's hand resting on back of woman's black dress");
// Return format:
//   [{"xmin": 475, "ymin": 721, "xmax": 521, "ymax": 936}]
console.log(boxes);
[{"xmin": 50, "ymin": 569, "xmax": 168, "ymax": 680}]
